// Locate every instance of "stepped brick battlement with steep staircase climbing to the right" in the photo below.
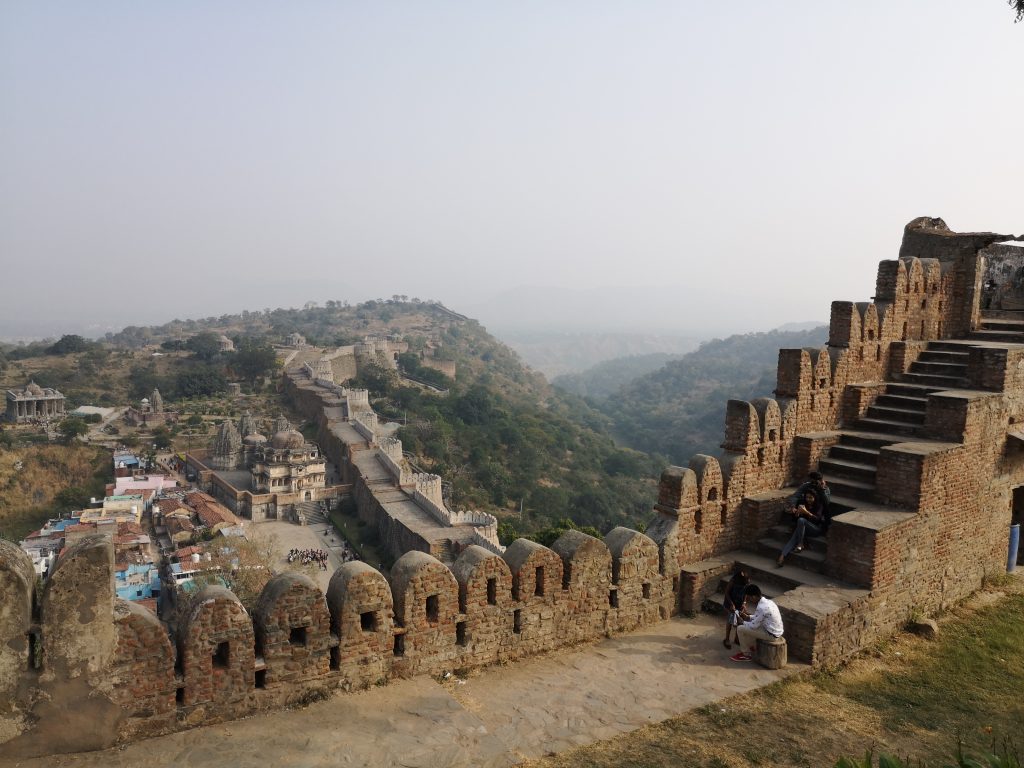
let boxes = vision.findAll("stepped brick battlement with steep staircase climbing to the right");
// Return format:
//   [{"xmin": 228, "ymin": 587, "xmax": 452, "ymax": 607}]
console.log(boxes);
[{"xmin": 655, "ymin": 219, "xmax": 1024, "ymax": 663}]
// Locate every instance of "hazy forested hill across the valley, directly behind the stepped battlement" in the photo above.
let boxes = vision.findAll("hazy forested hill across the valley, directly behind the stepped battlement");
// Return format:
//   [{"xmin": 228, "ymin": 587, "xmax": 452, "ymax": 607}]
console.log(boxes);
[{"xmin": 589, "ymin": 326, "xmax": 828, "ymax": 464}]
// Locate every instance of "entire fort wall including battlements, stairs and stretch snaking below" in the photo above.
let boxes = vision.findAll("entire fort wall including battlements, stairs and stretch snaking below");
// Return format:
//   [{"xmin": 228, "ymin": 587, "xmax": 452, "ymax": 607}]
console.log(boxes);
[{"xmin": 0, "ymin": 219, "xmax": 1024, "ymax": 757}]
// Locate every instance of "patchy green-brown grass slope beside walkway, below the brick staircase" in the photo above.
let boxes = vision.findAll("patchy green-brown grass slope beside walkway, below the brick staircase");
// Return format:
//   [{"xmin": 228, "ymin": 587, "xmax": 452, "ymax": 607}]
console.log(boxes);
[{"xmin": 529, "ymin": 579, "xmax": 1024, "ymax": 768}]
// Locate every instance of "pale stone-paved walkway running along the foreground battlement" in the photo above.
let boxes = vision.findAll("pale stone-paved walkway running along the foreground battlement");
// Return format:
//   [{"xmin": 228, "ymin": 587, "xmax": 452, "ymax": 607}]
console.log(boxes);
[{"xmin": 6, "ymin": 615, "xmax": 806, "ymax": 768}]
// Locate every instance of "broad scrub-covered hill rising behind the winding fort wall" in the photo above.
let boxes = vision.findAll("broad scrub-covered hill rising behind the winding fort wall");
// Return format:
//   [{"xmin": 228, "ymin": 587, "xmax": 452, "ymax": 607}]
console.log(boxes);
[{"xmin": 0, "ymin": 296, "xmax": 663, "ymax": 541}]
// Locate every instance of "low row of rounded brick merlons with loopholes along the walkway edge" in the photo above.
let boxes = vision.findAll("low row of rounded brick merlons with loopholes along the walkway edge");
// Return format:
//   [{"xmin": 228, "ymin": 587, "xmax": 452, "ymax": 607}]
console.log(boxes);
[{"xmin": 0, "ymin": 528, "xmax": 676, "ymax": 756}]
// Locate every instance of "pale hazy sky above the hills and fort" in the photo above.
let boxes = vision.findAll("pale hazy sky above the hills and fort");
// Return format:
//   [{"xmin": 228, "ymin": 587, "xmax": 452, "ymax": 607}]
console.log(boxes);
[{"xmin": 0, "ymin": 0, "xmax": 1024, "ymax": 337}]
